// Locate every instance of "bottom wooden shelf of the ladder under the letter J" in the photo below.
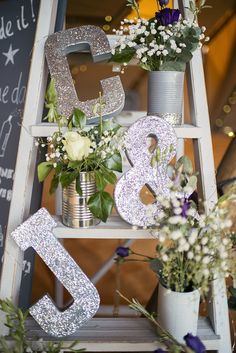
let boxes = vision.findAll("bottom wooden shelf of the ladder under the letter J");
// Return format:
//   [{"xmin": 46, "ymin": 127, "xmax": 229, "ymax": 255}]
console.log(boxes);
[{"xmin": 20, "ymin": 317, "xmax": 220, "ymax": 352}]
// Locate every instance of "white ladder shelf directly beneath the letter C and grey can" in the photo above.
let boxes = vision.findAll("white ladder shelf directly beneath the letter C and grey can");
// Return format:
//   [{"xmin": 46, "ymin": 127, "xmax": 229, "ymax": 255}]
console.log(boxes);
[{"xmin": 30, "ymin": 120, "xmax": 202, "ymax": 139}]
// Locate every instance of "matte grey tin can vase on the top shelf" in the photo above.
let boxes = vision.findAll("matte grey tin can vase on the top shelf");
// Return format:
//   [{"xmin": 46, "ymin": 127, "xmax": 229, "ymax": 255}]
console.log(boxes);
[{"xmin": 147, "ymin": 71, "xmax": 184, "ymax": 125}]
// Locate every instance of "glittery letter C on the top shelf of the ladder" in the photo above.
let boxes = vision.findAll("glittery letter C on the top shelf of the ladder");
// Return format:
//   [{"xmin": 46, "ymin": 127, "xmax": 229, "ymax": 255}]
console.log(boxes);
[{"xmin": 45, "ymin": 25, "xmax": 125, "ymax": 123}]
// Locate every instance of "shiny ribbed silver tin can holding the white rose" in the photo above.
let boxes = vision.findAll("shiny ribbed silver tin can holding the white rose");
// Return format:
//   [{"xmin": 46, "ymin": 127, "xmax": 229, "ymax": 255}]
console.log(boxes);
[{"xmin": 62, "ymin": 172, "xmax": 100, "ymax": 228}]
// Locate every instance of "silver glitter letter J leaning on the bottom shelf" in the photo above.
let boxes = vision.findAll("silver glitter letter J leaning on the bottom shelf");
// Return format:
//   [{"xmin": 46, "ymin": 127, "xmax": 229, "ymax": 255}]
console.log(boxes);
[{"xmin": 11, "ymin": 208, "xmax": 100, "ymax": 337}]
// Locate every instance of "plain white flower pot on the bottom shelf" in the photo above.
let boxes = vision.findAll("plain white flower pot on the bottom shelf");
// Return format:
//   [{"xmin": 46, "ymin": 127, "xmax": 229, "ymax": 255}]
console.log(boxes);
[{"xmin": 157, "ymin": 283, "xmax": 200, "ymax": 343}]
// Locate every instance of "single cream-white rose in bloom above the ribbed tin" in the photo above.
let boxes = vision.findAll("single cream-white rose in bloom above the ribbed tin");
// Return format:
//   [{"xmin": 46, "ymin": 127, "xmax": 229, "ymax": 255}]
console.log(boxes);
[{"xmin": 62, "ymin": 131, "xmax": 91, "ymax": 161}]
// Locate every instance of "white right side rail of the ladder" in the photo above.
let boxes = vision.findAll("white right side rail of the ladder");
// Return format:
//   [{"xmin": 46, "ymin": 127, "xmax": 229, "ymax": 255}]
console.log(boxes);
[{"xmin": 179, "ymin": 0, "xmax": 231, "ymax": 353}]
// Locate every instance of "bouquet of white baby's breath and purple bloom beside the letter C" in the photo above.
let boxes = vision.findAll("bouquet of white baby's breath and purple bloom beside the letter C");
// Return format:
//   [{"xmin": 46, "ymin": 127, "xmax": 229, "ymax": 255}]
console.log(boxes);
[{"xmin": 111, "ymin": 0, "xmax": 210, "ymax": 71}]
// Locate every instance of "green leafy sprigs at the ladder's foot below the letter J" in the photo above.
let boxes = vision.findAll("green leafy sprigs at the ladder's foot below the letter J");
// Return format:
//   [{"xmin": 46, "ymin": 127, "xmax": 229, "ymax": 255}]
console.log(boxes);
[{"xmin": 0, "ymin": 299, "xmax": 85, "ymax": 353}]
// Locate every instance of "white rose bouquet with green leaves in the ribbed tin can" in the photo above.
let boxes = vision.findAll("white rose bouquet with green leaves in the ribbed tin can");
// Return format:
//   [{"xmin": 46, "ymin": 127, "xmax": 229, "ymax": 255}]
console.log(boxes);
[{"xmin": 36, "ymin": 81, "xmax": 122, "ymax": 222}]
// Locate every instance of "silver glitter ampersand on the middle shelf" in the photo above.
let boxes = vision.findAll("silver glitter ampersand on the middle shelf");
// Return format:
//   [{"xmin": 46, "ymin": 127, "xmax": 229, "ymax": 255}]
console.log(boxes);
[{"xmin": 114, "ymin": 116, "xmax": 177, "ymax": 226}]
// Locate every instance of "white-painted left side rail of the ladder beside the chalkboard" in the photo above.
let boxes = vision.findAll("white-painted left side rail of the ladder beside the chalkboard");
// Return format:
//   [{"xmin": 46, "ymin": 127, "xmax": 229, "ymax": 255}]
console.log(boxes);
[{"xmin": 0, "ymin": 0, "xmax": 57, "ymax": 333}]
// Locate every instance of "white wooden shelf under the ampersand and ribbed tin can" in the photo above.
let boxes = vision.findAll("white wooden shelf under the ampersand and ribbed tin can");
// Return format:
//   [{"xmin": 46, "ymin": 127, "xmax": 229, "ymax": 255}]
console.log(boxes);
[{"xmin": 53, "ymin": 216, "xmax": 155, "ymax": 239}]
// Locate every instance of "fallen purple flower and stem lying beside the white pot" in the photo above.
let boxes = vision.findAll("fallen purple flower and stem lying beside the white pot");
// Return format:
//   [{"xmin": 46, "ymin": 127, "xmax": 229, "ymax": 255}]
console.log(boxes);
[{"xmin": 118, "ymin": 292, "xmax": 206, "ymax": 353}]
